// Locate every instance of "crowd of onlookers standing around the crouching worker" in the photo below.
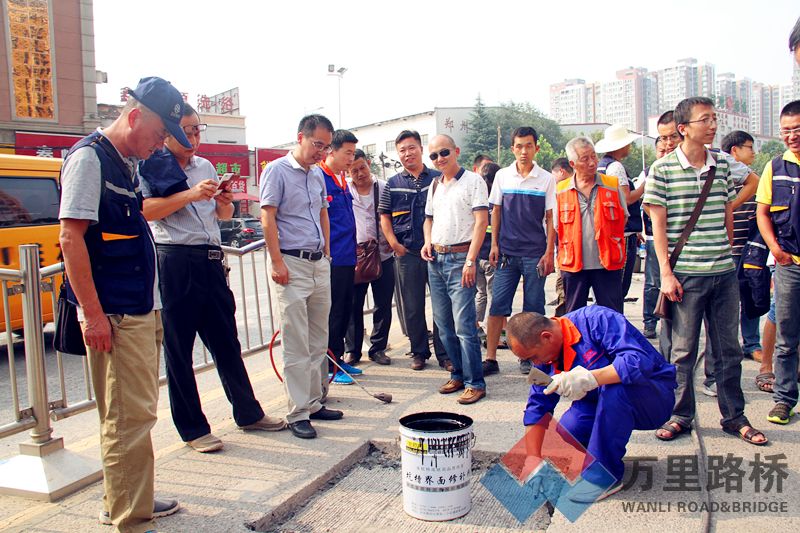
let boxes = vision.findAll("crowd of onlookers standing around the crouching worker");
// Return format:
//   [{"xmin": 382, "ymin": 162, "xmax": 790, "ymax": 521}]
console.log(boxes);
[{"xmin": 53, "ymin": 16, "xmax": 800, "ymax": 531}]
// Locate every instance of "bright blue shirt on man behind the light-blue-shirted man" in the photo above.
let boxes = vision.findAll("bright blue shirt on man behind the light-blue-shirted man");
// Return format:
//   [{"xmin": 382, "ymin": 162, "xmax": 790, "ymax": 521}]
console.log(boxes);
[{"xmin": 320, "ymin": 166, "xmax": 356, "ymax": 267}]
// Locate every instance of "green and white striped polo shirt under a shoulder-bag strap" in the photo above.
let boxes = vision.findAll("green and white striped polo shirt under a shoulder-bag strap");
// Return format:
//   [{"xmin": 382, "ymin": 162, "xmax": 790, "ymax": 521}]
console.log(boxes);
[{"xmin": 644, "ymin": 146, "xmax": 736, "ymax": 276}]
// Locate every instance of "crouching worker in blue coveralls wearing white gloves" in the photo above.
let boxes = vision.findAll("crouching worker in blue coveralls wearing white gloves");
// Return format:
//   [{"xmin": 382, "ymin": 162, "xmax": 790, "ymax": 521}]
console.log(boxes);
[{"xmin": 506, "ymin": 305, "xmax": 677, "ymax": 503}]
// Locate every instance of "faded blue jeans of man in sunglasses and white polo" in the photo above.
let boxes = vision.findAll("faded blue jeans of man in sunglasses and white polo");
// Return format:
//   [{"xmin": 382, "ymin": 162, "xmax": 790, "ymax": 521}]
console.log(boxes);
[{"xmin": 428, "ymin": 252, "xmax": 486, "ymax": 390}]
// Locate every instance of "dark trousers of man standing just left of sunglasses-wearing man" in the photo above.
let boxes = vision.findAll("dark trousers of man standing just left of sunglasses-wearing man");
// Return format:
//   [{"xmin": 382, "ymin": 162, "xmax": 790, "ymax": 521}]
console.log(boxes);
[{"xmin": 395, "ymin": 252, "xmax": 449, "ymax": 364}]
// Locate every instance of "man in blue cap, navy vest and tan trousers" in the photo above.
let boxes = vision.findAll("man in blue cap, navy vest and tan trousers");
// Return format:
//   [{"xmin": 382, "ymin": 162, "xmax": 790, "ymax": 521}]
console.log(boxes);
[{"xmin": 59, "ymin": 77, "xmax": 186, "ymax": 532}]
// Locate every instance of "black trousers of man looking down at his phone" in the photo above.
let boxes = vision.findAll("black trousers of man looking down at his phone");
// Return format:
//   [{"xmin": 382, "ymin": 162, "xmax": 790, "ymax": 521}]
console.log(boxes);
[{"xmin": 158, "ymin": 246, "xmax": 264, "ymax": 441}]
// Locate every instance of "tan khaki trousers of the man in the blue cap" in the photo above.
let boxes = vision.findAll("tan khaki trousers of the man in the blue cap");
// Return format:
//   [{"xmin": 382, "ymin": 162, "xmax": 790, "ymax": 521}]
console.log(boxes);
[{"xmin": 87, "ymin": 311, "xmax": 163, "ymax": 533}]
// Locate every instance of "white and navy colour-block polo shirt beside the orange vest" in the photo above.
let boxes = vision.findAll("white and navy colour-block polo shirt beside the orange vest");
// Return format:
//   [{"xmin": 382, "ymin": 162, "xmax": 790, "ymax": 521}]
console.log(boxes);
[{"xmin": 489, "ymin": 162, "xmax": 556, "ymax": 258}]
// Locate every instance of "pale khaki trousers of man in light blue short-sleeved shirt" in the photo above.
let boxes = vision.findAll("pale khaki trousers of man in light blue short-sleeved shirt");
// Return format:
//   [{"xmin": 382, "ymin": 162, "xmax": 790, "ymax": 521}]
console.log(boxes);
[{"xmin": 272, "ymin": 255, "xmax": 331, "ymax": 424}]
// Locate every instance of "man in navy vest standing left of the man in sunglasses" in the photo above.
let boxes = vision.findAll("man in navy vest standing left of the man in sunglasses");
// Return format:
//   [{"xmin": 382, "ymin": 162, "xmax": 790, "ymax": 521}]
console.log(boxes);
[{"xmin": 378, "ymin": 130, "xmax": 452, "ymax": 372}]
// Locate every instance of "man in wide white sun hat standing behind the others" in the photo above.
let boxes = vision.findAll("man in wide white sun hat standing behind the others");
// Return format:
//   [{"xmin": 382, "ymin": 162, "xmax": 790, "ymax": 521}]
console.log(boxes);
[{"xmin": 595, "ymin": 125, "xmax": 644, "ymax": 308}]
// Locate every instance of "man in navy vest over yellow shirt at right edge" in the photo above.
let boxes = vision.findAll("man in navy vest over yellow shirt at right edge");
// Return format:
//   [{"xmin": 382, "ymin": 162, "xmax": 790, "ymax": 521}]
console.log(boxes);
[{"xmin": 756, "ymin": 100, "xmax": 800, "ymax": 424}]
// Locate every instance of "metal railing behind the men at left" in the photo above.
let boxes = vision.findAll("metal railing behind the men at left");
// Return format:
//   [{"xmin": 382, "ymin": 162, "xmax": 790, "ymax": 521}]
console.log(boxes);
[{"xmin": 0, "ymin": 239, "xmax": 374, "ymax": 439}]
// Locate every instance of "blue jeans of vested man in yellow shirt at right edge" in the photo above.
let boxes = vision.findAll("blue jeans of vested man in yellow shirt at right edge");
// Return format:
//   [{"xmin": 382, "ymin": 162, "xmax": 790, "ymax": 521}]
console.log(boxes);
[{"xmin": 772, "ymin": 264, "xmax": 800, "ymax": 407}]
